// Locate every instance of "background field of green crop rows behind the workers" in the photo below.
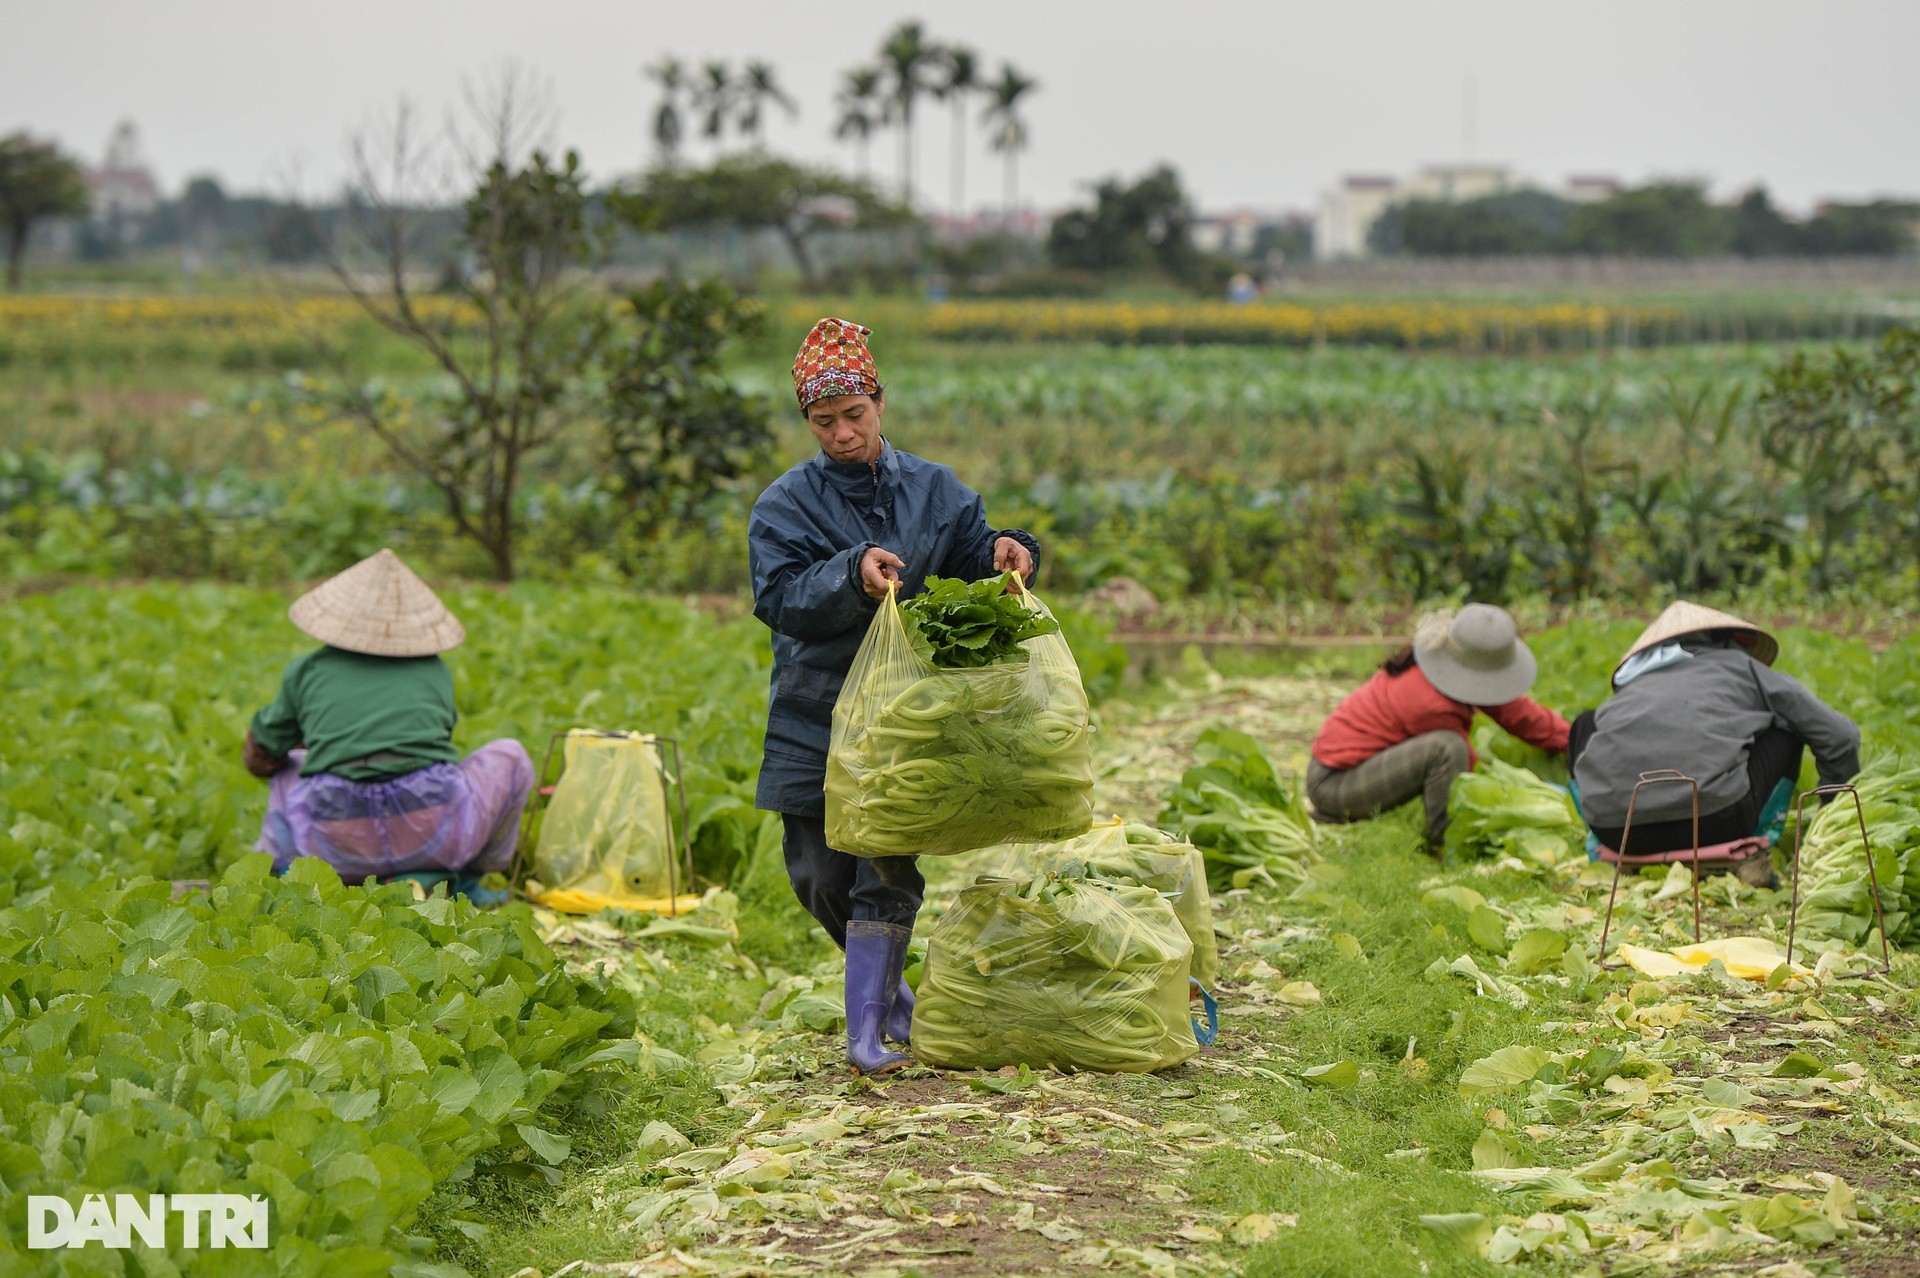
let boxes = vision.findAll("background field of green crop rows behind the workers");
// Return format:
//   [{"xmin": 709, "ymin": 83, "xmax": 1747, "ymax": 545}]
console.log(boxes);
[{"xmin": 11, "ymin": 297, "xmax": 1920, "ymax": 614}]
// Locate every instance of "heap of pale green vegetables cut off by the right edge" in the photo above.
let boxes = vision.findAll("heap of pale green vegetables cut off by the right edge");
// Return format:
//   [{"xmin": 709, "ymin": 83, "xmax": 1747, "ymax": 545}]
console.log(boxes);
[{"xmin": 1799, "ymin": 758, "xmax": 1920, "ymax": 946}]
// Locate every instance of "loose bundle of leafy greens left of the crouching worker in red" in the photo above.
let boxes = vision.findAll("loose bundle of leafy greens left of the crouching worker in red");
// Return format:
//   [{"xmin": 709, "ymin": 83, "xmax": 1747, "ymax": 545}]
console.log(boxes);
[{"xmin": 1160, "ymin": 727, "xmax": 1313, "ymax": 887}]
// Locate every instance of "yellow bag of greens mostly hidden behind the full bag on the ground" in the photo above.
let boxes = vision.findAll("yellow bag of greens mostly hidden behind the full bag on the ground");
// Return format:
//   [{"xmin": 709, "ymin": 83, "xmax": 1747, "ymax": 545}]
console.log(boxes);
[{"xmin": 968, "ymin": 819, "xmax": 1219, "ymax": 990}]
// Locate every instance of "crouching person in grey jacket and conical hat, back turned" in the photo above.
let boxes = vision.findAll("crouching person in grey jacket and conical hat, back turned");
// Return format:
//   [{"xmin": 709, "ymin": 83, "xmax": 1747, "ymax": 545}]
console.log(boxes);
[{"xmin": 1567, "ymin": 601, "xmax": 1860, "ymax": 856}]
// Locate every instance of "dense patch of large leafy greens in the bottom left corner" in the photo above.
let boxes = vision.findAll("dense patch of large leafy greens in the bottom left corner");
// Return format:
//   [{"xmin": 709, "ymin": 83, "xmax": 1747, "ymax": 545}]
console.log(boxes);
[{"xmin": 0, "ymin": 856, "xmax": 637, "ymax": 1278}]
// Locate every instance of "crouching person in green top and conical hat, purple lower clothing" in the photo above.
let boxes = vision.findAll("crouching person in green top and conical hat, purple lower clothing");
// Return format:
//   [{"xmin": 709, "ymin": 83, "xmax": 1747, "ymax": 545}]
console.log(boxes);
[{"xmin": 246, "ymin": 551, "xmax": 534, "ymax": 896}]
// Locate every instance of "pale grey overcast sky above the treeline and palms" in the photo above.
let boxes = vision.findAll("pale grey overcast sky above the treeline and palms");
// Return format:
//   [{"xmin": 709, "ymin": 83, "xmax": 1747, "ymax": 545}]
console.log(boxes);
[{"xmin": 0, "ymin": 0, "xmax": 1920, "ymax": 209}]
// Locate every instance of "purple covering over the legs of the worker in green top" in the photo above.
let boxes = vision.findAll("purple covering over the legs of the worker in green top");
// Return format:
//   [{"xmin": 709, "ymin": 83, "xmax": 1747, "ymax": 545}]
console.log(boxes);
[{"xmin": 253, "ymin": 741, "xmax": 534, "ymax": 883}]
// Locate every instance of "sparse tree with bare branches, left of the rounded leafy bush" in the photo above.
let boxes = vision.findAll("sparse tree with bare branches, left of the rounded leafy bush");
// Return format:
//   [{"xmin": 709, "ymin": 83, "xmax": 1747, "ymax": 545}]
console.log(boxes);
[{"xmin": 303, "ymin": 69, "xmax": 601, "ymax": 580}]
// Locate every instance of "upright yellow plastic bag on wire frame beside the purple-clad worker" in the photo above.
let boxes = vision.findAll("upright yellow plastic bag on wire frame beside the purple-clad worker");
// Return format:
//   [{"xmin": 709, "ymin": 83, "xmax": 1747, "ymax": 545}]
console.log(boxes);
[{"xmin": 528, "ymin": 731, "xmax": 685, "ymax": 913}]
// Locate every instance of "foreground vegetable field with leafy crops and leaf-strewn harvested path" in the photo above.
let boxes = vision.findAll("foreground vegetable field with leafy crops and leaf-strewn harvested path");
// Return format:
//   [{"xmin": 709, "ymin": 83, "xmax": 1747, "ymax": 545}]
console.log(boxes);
[{"xmin": 0, "ymin": 583, "xmax": 1920, "ymax": 1278}]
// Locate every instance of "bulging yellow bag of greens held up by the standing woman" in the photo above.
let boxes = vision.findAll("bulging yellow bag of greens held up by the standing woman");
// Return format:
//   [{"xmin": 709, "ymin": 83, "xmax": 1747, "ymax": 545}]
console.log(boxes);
[{"xmin": 826, "ymin": 578, "xmax": 1092, "ymax": 856}]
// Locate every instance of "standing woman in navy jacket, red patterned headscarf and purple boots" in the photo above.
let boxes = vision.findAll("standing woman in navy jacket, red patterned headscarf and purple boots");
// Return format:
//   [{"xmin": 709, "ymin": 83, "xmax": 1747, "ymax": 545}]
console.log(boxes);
[{"xmin": 747, "ymin": 319, "xmax": 1041, "ymax": 1073}]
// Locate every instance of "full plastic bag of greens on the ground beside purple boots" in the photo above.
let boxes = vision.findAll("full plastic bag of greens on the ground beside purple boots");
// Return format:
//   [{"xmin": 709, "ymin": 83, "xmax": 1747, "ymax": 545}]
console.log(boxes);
[{"xmin": 912, "ymin": 873, "xmax": 1200, "ymax": 1073}]
